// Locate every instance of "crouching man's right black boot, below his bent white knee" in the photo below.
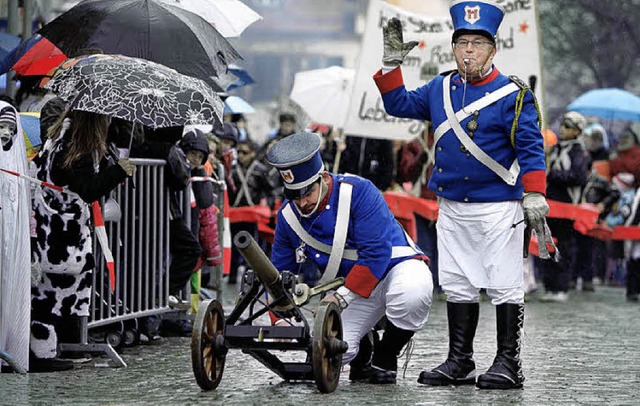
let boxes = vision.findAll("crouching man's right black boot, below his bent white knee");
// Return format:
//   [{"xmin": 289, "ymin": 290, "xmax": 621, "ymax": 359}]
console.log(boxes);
[{"xmin": 369, "ymin": 320, "xmax": 415, "ymax": 384}]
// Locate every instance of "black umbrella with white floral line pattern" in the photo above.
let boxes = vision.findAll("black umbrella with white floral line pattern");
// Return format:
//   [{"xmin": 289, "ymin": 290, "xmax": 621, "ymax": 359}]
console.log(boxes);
[{"xmin": 45, "ymin": 54, "xmax": 224, "ymax": 128}]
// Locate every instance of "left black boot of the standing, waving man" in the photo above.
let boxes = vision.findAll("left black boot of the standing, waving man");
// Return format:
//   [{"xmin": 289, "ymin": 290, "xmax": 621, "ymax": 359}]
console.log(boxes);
[{"xmin": 418, "ymin": 302, "xmax": 480, "ymax": 386}]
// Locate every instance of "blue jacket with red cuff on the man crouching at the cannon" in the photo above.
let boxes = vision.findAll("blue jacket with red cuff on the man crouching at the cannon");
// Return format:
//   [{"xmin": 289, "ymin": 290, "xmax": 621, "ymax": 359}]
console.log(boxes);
[{"xmin": 271, "ymin": 174, "xmax": 426, "ymax": 297}]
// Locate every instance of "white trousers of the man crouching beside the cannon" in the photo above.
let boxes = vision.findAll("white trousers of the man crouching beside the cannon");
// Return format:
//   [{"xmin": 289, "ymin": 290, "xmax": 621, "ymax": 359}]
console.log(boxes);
[{"xmin": 341, "ymin": 259, "xmax": 433, "ymax": 365}]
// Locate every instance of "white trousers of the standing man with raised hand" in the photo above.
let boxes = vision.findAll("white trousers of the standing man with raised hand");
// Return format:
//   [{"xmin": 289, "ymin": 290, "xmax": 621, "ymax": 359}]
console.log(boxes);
[{"xmin": 436, "ymin": 198, "xmax": 525, "ymax": 304}]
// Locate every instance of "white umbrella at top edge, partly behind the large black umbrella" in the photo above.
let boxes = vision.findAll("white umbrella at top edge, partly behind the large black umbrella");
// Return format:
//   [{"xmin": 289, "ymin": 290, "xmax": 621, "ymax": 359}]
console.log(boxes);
[{"xmin": 161, "ymin": 0, "xmax": 262, "ymax": 38}]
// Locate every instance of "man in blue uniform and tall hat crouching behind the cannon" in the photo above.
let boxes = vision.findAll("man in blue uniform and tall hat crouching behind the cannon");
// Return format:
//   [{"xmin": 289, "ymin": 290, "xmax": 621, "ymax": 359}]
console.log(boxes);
[{"xmin": 266, "ymin": 133, "xmax": 433, "ymax": 384}]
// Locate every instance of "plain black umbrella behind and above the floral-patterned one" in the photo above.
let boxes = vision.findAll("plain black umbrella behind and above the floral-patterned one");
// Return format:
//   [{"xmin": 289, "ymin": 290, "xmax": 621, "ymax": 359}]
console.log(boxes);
[{"xmin": 38, "ymin": 0, "xmax": 242, "ymax": 83}]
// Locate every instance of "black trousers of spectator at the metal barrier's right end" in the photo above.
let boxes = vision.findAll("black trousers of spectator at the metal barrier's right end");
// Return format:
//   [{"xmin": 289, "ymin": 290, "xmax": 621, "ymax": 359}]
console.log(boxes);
[{"xmin": 169, "ymin": 219, "xmax": 202, "ymax": 295}]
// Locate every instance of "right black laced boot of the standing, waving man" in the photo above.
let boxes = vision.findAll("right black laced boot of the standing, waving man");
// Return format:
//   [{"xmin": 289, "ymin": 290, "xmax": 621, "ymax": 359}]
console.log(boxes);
[{"xmin": 476, "ymin": 303, "xmax": 524, "ymax": 389}]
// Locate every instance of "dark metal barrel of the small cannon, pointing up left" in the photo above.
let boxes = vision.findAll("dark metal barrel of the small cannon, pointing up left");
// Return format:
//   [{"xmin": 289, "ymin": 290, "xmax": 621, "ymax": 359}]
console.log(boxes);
[{"xmin": 233, "ymin": 231, "xmax": 294, "ymax": 311}]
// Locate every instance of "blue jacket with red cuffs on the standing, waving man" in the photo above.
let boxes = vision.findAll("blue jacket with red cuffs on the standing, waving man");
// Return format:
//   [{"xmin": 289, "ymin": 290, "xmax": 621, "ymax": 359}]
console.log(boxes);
[{"xmin": 374, "ymin": 67, "xmax": 546, "ymax": 202}]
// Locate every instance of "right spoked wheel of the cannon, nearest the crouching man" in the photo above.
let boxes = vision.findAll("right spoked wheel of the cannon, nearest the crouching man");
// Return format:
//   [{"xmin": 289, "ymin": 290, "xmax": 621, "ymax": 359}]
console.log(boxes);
[{"xmin": 311, "ymin": 302, "xmax": 347, "ymax": 393}]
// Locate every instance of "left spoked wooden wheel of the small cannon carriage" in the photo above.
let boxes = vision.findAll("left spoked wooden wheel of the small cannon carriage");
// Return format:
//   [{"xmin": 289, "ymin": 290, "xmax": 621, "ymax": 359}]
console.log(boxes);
[{"xmin": 191, "ymin": 300, "xmax": 227, "ymax": 390}]
